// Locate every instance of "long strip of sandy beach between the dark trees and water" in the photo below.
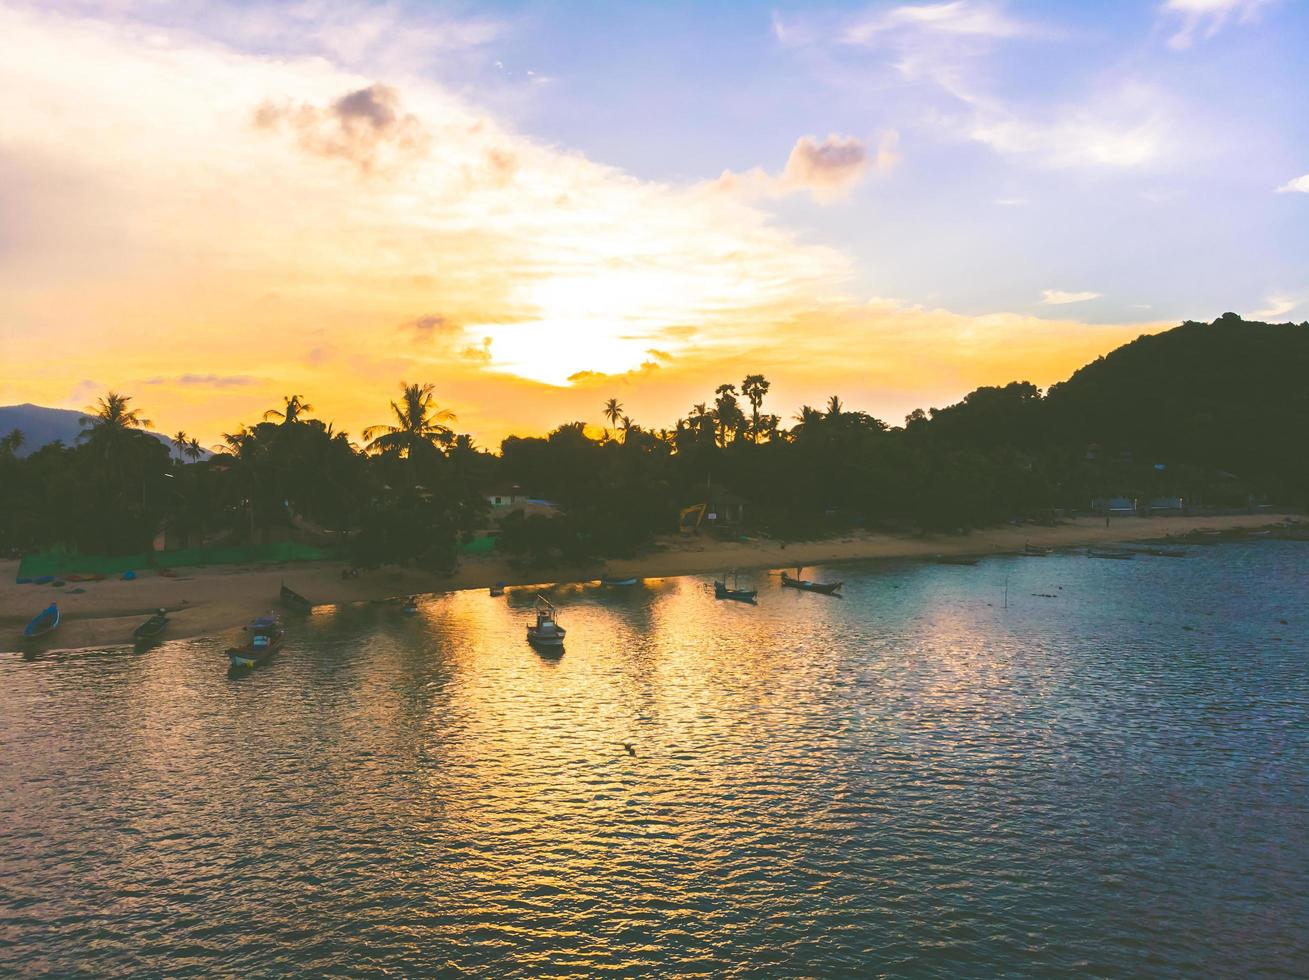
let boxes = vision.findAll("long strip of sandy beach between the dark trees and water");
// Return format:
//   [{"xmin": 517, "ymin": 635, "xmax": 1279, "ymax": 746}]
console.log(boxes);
[{"xmin": 0, "ymin": 513, "xmax": 1297, "ymax": 653}]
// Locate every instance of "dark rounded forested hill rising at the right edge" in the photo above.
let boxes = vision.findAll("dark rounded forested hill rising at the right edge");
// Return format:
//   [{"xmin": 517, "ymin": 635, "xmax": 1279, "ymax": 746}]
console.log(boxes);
[{"xmin": 911, "ymin": 313, "xmax": 1309, "ymax": 493}]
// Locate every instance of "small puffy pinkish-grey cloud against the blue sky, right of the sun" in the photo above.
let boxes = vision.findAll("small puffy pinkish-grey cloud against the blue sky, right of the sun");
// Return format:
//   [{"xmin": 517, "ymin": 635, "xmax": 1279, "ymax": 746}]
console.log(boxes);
[{"xmin": 715, "ymin": 131, "xmax": 901, "ymax": 204}]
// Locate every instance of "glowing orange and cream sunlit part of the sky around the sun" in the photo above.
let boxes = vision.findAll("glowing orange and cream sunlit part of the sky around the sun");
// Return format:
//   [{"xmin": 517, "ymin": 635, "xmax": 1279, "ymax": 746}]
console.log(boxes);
[{"xmin": 0, "ymin": 2, "xmax": 1170, "ymax": 445}]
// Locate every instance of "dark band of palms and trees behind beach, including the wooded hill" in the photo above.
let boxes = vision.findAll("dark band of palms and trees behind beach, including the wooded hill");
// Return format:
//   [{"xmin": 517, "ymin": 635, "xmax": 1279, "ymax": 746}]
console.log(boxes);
[{"xmin": 0, "ymin": 314, "xmax": 1309, "ymax": 568}]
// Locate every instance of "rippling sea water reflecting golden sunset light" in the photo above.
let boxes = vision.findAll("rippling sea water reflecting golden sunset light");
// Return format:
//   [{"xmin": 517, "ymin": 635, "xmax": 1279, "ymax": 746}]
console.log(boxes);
[{"xmin": 0, "ymin": 542, "xmax": 1309, "ymax": 977}]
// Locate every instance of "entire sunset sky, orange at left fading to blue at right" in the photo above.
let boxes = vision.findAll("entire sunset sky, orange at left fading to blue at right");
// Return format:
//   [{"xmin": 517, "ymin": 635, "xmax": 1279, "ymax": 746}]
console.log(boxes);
[{"xmin": 0, "ymin": 0, "xmax": 1309, "ymax": 446}]
